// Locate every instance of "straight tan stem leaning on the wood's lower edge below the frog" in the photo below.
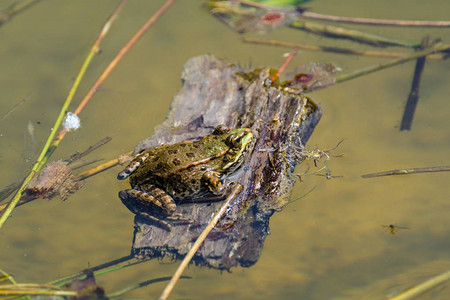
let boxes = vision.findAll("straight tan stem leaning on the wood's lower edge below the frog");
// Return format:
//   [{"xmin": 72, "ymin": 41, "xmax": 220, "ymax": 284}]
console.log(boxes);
[{"xmin": 159, "ymin": 184, "xmax": 242, "ymax": 300}]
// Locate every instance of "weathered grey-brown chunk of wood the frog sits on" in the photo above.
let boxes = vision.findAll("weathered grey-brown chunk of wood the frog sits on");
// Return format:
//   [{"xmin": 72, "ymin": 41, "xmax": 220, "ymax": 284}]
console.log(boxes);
[{"xmin": 128, "ymin": 55, "xmax": 321, "ymax": 270}]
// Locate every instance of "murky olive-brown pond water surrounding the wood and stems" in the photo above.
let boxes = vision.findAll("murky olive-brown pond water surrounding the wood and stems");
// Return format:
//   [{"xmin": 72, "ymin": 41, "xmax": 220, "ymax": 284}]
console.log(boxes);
[{"xmin": 0, "ymin": 0, "xmax": 450, "ymax": 299}]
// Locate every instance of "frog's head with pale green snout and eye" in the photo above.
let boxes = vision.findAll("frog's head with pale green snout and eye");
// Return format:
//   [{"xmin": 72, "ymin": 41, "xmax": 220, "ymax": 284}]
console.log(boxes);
[{"xmin": 213, "ymin": 126, "xmax": 253, "ymax": 173}]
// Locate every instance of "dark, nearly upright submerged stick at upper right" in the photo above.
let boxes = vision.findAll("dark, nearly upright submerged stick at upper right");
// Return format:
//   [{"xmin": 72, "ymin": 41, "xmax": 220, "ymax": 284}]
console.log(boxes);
[{"xmin": 400, "ymin": 36, "xmax": 430, "ymax": 131}]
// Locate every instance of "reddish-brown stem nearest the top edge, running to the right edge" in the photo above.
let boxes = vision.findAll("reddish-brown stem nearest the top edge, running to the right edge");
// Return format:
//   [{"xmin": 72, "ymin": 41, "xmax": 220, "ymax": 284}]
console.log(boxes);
[{"xmin": 301, "ymin": 11, "xmax": 450, "ymax": 27}]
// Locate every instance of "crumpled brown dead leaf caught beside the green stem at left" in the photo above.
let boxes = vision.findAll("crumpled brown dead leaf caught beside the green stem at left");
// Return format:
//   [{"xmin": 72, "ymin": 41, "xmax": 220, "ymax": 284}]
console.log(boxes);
[{"xmin": 25, "ymin": 160, "xmax": 83, "ymax": 201}]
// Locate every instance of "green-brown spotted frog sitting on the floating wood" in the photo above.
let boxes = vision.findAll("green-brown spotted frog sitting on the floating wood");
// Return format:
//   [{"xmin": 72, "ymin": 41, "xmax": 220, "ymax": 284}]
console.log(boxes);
[{"xmin": 117, "ymin": 125, "xmax": 254, "ymax": 231}]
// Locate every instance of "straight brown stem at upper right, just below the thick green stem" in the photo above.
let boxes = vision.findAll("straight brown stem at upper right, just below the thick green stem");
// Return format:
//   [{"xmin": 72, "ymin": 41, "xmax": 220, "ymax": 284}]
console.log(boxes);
[{"xmin": 243, "ymin": 38, "xmax": 444, "ymax": 60}]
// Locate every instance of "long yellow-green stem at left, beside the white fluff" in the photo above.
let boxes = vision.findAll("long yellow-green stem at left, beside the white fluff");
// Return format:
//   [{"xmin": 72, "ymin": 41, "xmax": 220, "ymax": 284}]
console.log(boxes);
[{"xmin": 0, "ymin": 1, "xmax": 125, "ymax": 228}]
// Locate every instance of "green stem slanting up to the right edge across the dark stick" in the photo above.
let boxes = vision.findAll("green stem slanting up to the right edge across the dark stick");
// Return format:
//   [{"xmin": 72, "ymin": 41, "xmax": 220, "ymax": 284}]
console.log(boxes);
[{"xmin": 336, "ymin": 44, "xmax": 450, "ymax": 83}]
